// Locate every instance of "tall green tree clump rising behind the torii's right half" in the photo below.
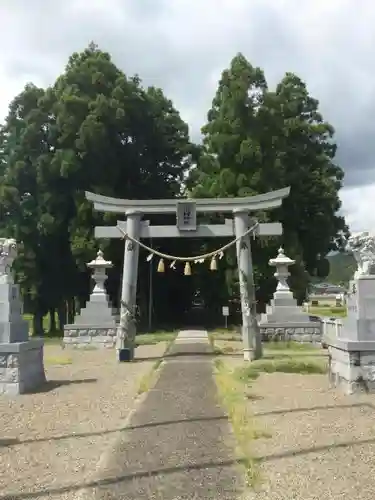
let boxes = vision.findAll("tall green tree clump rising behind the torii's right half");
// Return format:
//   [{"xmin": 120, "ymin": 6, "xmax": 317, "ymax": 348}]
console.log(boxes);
[{"xmin": 189, "ymin": 54, "xmax": 347, "ymax": 301}]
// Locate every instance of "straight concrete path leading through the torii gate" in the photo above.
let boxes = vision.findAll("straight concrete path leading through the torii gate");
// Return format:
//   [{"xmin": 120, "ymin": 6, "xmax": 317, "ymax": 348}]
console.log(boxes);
[{"xmin": 90, "ymin": 330, "xmax": 242, "ymax": 500}]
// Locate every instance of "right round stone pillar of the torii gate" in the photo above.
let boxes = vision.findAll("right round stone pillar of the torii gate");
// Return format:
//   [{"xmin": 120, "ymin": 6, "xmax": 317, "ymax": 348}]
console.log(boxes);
[{"xmin": 233, "ymin": 209, "xmax": 262, "ymax": 361}]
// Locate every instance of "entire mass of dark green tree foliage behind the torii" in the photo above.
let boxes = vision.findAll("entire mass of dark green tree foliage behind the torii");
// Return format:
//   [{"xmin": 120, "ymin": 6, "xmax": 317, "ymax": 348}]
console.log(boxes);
[{"xmin": 0, "ymin": 44, "xmax": 347, "ymax": 334}]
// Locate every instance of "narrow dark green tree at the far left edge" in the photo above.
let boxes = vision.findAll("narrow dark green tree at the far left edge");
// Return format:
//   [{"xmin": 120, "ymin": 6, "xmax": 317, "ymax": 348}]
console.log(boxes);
[{"xmin": 1, "ymin": 84, "xmax": 61, "ymax": 333}]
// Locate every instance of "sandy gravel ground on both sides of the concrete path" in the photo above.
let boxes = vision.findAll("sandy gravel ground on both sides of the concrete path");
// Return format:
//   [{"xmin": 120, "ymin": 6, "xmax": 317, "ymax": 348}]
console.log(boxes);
[{"xmin": 0, "ymin": 336, "xmax": 375, "ymax": 500}]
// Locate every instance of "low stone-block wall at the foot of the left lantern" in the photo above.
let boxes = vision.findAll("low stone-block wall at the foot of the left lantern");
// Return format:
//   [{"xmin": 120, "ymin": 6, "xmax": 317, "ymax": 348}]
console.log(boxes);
[{"xmin": 63, "ymin": 325, "xmax": 116, "ymax": 348}]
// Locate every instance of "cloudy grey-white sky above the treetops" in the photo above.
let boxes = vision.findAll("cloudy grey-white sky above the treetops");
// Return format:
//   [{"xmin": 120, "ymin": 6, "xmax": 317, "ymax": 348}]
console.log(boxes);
[{"xmin": 0, "ymin": 0, "xmax": 375, "ymax": 230}]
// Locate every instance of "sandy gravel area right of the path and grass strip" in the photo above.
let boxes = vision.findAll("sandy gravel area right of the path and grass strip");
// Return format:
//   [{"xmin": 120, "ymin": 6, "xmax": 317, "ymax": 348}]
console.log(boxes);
[{"xmin": 242, "ymin": 373, "xmax": 375, "ymax": 500}]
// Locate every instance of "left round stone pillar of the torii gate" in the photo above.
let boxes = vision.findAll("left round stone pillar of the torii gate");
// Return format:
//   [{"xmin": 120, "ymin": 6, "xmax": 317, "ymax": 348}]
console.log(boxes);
[{"xmin": 117, "ymin": 211, "xmax": 142, "ymax": 361}]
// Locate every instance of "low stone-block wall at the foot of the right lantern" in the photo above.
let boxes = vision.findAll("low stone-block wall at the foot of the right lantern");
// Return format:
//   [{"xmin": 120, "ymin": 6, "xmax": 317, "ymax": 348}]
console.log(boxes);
[{"xmin": 260, "ymin": 323, "xmax": 322, "ymax": 343}]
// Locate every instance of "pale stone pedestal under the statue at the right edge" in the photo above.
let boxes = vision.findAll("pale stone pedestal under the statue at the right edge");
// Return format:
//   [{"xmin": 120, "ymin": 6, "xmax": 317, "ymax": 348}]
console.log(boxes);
[{"xmin": 324, "ymin": 275, "xmax": 375, "ymax": 394}]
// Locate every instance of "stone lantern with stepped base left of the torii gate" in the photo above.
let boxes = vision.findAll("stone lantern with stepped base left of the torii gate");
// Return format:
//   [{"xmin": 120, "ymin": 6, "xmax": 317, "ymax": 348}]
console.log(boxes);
[{"xmin": 63, "ymin": 250, "xmax": 116, "ymax": 347}]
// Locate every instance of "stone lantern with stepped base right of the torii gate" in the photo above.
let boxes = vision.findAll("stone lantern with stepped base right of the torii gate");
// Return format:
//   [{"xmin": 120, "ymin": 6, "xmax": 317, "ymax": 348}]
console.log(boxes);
[{"xmin": 259, "ymin": 248, "xmax": 322, "ymax": 342}]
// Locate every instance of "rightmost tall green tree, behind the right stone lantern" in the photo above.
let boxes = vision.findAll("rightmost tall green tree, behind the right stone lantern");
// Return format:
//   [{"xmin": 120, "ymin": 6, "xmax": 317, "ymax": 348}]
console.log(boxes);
[{"xmin": 265, "ymin": 73, "xmax": 348, "ymax": 275}]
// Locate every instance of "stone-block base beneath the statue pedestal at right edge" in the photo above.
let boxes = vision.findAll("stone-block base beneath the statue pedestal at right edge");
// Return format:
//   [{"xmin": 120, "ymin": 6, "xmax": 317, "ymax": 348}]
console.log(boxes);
[{"xmin": 328, "ymin": 340, "xmax": 375, "ymax": 394}]
